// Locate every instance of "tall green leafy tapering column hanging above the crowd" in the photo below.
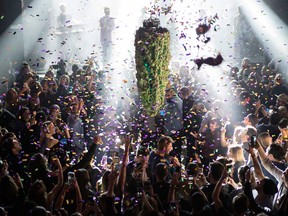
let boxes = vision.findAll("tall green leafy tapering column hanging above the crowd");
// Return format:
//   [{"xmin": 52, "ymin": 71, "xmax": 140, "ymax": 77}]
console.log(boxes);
[{"xmin": 135, "ymin": 18, "xmax": 171, "ymax": 116}]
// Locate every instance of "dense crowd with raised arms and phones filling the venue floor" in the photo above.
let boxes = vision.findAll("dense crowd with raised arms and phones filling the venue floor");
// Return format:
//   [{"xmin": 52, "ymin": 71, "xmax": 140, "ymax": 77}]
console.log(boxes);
[{"xmin": 0, "ymin": 51, "xmax": 288, "ymax": 216}]
